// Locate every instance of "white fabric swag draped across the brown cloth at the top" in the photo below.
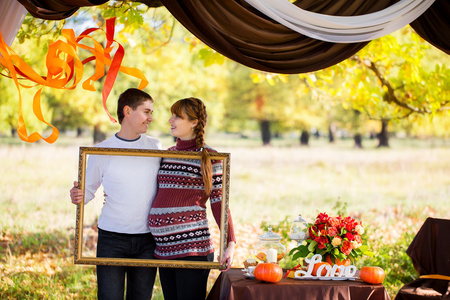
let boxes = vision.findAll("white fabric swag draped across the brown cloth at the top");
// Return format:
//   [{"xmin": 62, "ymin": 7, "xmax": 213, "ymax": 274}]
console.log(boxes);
[{"xmin": 245, "ymin": 0, "xmax": 434, "ymax": 43}]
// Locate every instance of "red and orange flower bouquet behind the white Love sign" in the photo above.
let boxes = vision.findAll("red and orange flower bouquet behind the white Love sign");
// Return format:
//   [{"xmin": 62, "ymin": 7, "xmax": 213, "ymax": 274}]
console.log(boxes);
[{"xmin": 289, "ymin": 213, "xmax": 373, "ymax": 263}]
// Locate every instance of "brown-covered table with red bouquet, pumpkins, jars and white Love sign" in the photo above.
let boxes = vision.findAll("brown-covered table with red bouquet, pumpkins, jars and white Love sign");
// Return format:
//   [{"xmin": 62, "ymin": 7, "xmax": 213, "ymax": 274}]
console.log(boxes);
[{"xmin": 207, "ymin": 213, "xmax": 390, "ymax": 300}]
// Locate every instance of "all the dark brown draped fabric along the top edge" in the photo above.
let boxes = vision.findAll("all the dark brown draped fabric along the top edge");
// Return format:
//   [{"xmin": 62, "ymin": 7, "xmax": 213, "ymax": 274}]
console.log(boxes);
[{"xmin": 14, "ymin": 0, "xmax": 450, "ymax": 74}]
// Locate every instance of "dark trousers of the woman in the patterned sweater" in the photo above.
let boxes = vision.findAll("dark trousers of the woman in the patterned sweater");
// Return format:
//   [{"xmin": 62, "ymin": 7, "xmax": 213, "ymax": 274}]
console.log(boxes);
[{"xmin": 159, "ymin": 253, "xmax": 214, "ymax": 300}]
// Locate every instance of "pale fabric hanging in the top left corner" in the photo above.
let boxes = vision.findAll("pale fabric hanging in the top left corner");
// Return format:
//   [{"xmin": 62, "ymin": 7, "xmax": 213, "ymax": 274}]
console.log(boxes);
[{"xmin": 0, "ymin": 0, "xmax": 27, "ymax": 46}]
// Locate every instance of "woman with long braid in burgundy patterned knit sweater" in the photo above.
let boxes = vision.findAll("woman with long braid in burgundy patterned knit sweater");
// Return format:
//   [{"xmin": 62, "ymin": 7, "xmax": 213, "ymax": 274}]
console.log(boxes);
[{"xmin": 148, "ymin": 98, "xmax": 236, "ymax": 300}]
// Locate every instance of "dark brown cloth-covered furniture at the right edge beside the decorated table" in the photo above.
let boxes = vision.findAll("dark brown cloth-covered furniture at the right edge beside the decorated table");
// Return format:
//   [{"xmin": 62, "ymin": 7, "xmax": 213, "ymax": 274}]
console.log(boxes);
[{"xmin": 395, "ymin": 218, "xmax": 450, "ymax": 300}]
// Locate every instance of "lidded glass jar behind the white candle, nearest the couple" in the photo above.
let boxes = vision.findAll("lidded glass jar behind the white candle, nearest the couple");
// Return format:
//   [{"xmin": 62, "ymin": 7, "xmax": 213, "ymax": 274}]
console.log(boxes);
[{"xmin": 254, "ymin": 226, "xmax": 286, "ymax": 263}]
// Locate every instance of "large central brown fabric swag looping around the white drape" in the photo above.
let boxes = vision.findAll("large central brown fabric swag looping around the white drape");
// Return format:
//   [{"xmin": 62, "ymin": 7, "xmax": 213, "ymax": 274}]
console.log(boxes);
[{"xmin": 162, "ymin": 0, "xmax": 396, "ymax": 74}]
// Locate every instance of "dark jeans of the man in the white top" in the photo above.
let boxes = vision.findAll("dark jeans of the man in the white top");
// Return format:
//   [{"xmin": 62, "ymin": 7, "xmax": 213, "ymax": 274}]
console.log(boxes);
[{"xmin": 97, "ymin": 228, "xmax": 157, "ymax": 300}]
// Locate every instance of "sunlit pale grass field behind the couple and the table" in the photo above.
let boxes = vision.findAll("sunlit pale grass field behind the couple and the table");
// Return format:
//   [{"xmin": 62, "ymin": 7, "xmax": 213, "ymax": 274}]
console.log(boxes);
[{"xmin": 0, "ymin": 135, "xmax": 450, "ymax": 299}]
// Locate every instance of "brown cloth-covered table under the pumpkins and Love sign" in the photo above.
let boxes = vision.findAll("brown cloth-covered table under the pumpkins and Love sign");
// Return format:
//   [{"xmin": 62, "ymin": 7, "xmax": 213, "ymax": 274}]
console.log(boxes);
[{"xmin": 207, "ymin": 269, "xmax": 390, "ymax": 300}]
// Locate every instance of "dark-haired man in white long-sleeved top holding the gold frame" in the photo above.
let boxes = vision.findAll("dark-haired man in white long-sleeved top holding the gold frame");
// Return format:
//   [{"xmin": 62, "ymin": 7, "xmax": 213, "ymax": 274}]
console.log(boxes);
[{"xmin": 70, "ymin": 89, "xmax": 162, "ymax": 300}]
